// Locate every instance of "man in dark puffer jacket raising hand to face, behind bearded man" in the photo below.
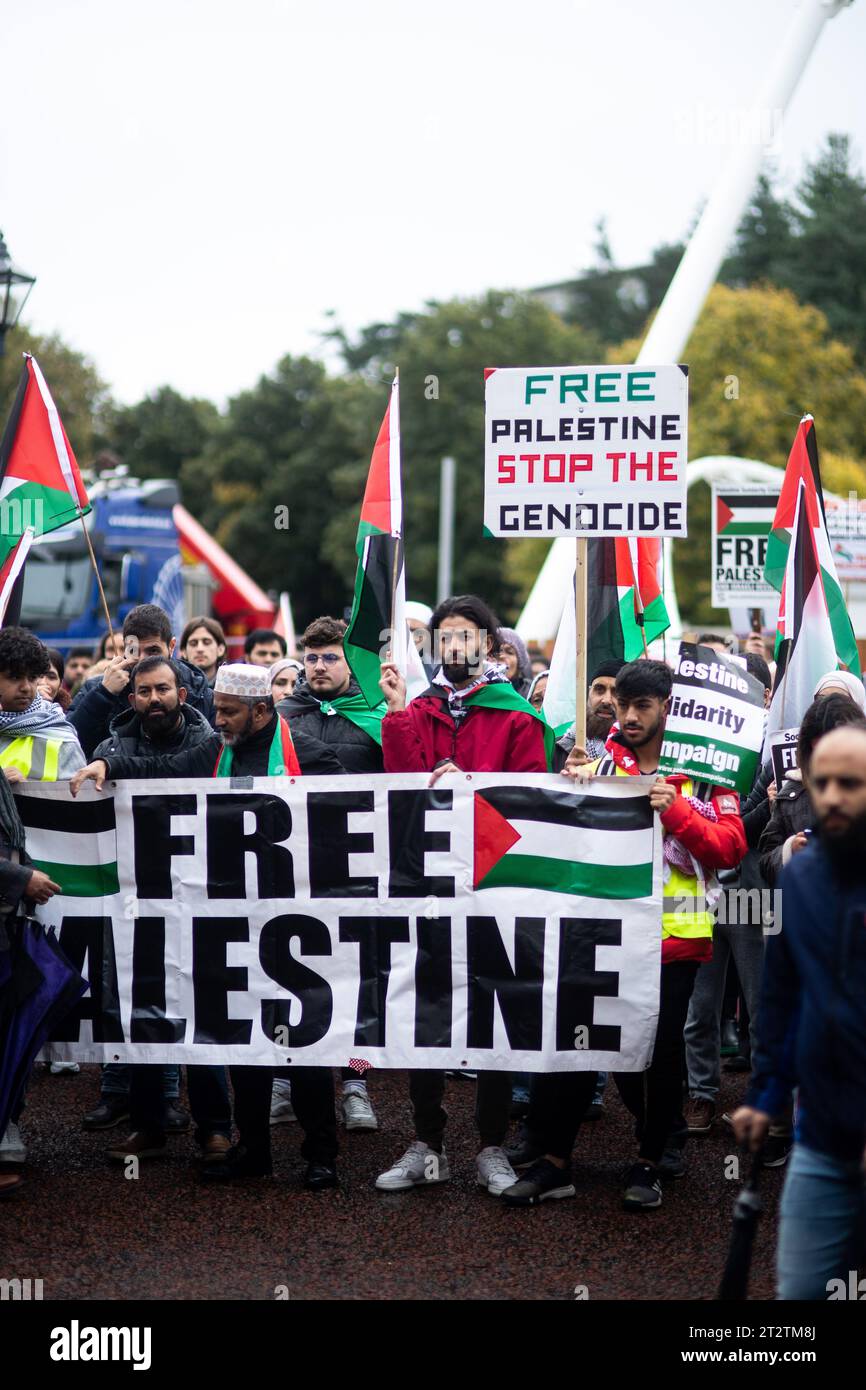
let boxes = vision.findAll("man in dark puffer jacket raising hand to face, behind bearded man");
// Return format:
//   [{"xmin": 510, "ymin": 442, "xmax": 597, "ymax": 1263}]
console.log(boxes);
[{"xmin": 70, "ymin": 603, "xmax": 214, "ymax": 758}]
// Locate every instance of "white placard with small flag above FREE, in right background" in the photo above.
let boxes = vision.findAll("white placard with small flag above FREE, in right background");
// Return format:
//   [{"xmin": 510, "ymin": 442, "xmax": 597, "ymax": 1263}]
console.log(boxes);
[{"xmin": 710, "ymin": 482, "xmax": 778, "ymax": 607}]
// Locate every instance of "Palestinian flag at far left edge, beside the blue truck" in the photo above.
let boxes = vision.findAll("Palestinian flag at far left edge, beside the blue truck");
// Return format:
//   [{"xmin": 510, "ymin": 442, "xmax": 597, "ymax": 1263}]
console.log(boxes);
[{"xmin": 0, "ymin": 353, "xmax": 90, "ymax": 564}]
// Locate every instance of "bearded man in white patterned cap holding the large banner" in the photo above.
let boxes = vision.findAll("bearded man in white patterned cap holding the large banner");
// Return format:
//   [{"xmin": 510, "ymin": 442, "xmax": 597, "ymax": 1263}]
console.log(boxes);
[{"xmin": 71, "ymin": 663, "xmax": 343, "ymax": 1191}]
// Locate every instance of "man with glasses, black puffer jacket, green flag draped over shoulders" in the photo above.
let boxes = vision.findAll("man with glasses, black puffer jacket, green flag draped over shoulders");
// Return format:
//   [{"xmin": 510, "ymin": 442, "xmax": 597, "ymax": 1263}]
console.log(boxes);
[{"xmin": 277, "ymin": 617, "xmax": 385, "ymax": 773}]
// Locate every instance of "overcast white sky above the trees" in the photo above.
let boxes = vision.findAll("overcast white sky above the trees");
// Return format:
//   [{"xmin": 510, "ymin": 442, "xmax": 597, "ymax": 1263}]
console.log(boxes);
[{"xmin": 0, "ymin": 0, "xmax": 866, "ymax": 402}]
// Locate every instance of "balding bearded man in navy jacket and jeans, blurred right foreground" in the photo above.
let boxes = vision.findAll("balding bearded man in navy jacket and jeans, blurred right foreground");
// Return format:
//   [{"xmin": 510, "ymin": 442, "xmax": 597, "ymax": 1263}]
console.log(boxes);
[{"xmin": 733, "ymin": 726, "xmax": 866, "ymax": 1300}]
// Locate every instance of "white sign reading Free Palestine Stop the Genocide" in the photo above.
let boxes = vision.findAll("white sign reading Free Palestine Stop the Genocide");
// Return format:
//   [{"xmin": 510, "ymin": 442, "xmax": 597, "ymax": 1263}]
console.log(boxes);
[{"xmin": 484, "ymin": 364, "xmax": 688, "ymax": 537}]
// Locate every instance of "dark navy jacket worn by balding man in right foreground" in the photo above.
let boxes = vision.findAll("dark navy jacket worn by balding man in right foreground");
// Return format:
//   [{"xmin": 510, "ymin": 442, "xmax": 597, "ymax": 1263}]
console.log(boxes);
[{"xmin": 746, "ymin": 840, "xmax": 866, "ymax": 1159}]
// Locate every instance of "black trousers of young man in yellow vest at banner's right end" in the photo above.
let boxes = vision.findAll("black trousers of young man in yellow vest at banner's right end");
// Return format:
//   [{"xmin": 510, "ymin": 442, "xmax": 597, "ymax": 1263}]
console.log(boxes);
[{"xmin": 613, "ymin": 960, "xmax": 699, "ymax": 1163}]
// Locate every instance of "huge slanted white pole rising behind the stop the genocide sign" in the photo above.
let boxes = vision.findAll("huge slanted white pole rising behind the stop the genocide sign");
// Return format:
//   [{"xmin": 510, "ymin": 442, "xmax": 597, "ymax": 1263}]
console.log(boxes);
[{"xmin": 517, "ymin": 0, "xmax": 852, "ymax": 639}]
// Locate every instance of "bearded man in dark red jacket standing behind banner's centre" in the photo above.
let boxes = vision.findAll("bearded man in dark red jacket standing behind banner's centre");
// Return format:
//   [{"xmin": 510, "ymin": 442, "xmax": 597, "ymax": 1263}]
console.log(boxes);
[{"xmin": 375, "ymin": 595, "xmax": 553, "ymax": 1197}]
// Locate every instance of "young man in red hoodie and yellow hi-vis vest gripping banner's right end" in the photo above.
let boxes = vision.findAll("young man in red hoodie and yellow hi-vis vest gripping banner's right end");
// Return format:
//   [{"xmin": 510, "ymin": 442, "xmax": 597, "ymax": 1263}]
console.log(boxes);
[{"xmin": 503, "ymin": 660, "xmax": 746, "ymax": 1211}]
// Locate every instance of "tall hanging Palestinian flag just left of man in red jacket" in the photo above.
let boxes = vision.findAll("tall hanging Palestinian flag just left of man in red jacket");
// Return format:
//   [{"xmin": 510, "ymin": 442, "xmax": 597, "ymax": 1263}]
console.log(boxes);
[{"xmin": 343, "ymin": 377, "xmax": 428, "ymax": 709}]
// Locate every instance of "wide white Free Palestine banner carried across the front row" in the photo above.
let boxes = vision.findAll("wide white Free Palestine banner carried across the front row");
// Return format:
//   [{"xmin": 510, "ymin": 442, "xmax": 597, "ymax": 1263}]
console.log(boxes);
[{"xmin": 27, "ymin": 773, "xmax": 662, "ymax": 1072}]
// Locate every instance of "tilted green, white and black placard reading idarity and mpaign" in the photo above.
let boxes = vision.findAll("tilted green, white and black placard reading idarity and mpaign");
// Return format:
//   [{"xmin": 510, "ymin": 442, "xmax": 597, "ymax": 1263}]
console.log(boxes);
[{"xmin": 659, "ymin": 642, "xmax": 765, "ymax": 794}]
